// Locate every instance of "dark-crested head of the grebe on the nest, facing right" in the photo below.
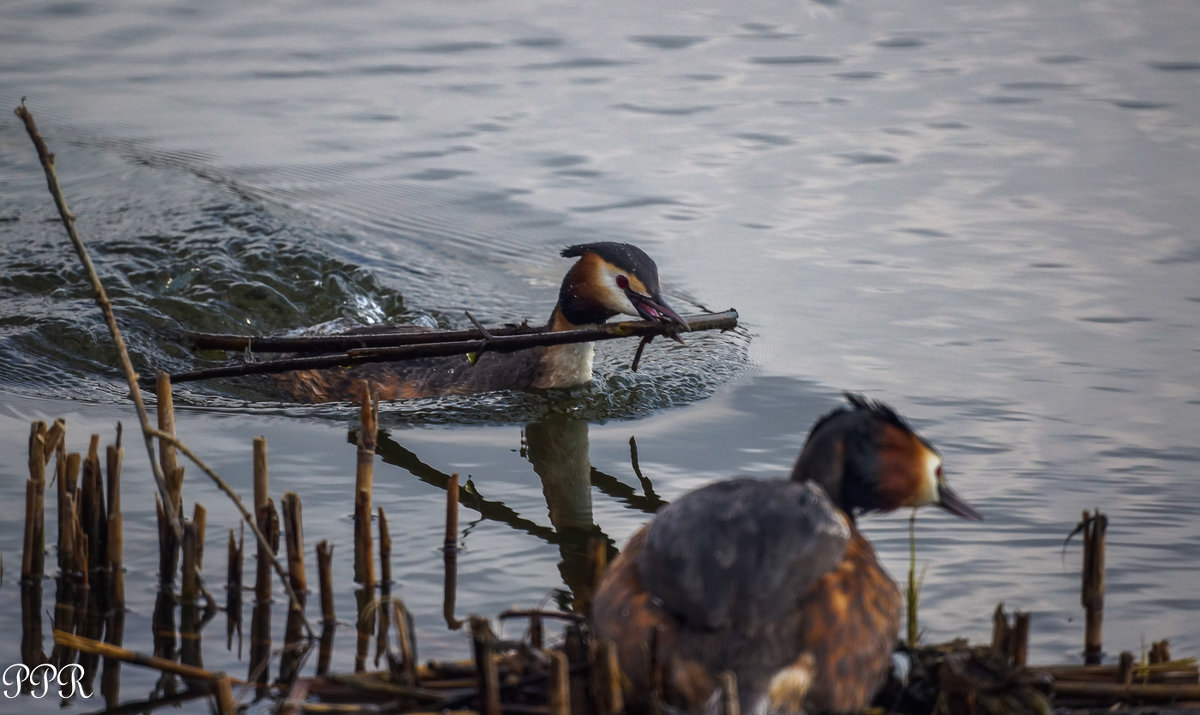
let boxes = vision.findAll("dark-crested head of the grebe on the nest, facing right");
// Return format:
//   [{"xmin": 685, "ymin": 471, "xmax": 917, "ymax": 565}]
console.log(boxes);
[{"xmin": 792, "ymin": 392, "xmax": 983, "ymax": 521}]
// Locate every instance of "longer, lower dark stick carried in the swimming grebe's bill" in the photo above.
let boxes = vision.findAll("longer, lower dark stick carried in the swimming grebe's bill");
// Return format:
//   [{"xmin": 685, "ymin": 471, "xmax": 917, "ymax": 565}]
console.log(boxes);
[{"xmin": 170, "ymin": 310, "xmax": 738, "ymax": 383}]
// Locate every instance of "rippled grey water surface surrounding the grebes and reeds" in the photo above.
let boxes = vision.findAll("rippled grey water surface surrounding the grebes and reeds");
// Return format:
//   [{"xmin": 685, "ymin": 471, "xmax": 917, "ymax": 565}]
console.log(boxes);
[{"xmin": 0, "ymin": 1, "xmax": 1200, "ymax": 709}]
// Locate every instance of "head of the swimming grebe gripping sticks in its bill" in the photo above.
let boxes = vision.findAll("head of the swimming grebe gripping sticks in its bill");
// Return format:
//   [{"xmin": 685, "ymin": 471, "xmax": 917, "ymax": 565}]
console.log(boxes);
[{"xmin": 557, "ymin": 241, "xmax": 688, "ymax": 329}]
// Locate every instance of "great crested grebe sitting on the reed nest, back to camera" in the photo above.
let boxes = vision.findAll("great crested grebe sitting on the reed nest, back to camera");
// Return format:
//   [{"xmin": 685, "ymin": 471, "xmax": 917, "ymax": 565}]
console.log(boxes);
[{"xmin": 592, "ymin": 395, "xmax": 983, "ymax": 713}]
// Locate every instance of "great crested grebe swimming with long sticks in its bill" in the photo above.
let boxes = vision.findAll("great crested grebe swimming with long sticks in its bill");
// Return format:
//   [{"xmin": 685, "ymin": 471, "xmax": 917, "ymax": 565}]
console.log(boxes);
[{"xmin": 276, "ymin": 241, "xmax": 688, "ymax": 402}]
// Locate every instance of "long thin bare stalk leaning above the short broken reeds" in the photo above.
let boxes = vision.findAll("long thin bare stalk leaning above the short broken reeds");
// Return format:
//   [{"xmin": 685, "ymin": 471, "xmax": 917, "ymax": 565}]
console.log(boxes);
[{"xmin": 16, "ymin": 101, "xmax": 184, "ymax": 539}]
